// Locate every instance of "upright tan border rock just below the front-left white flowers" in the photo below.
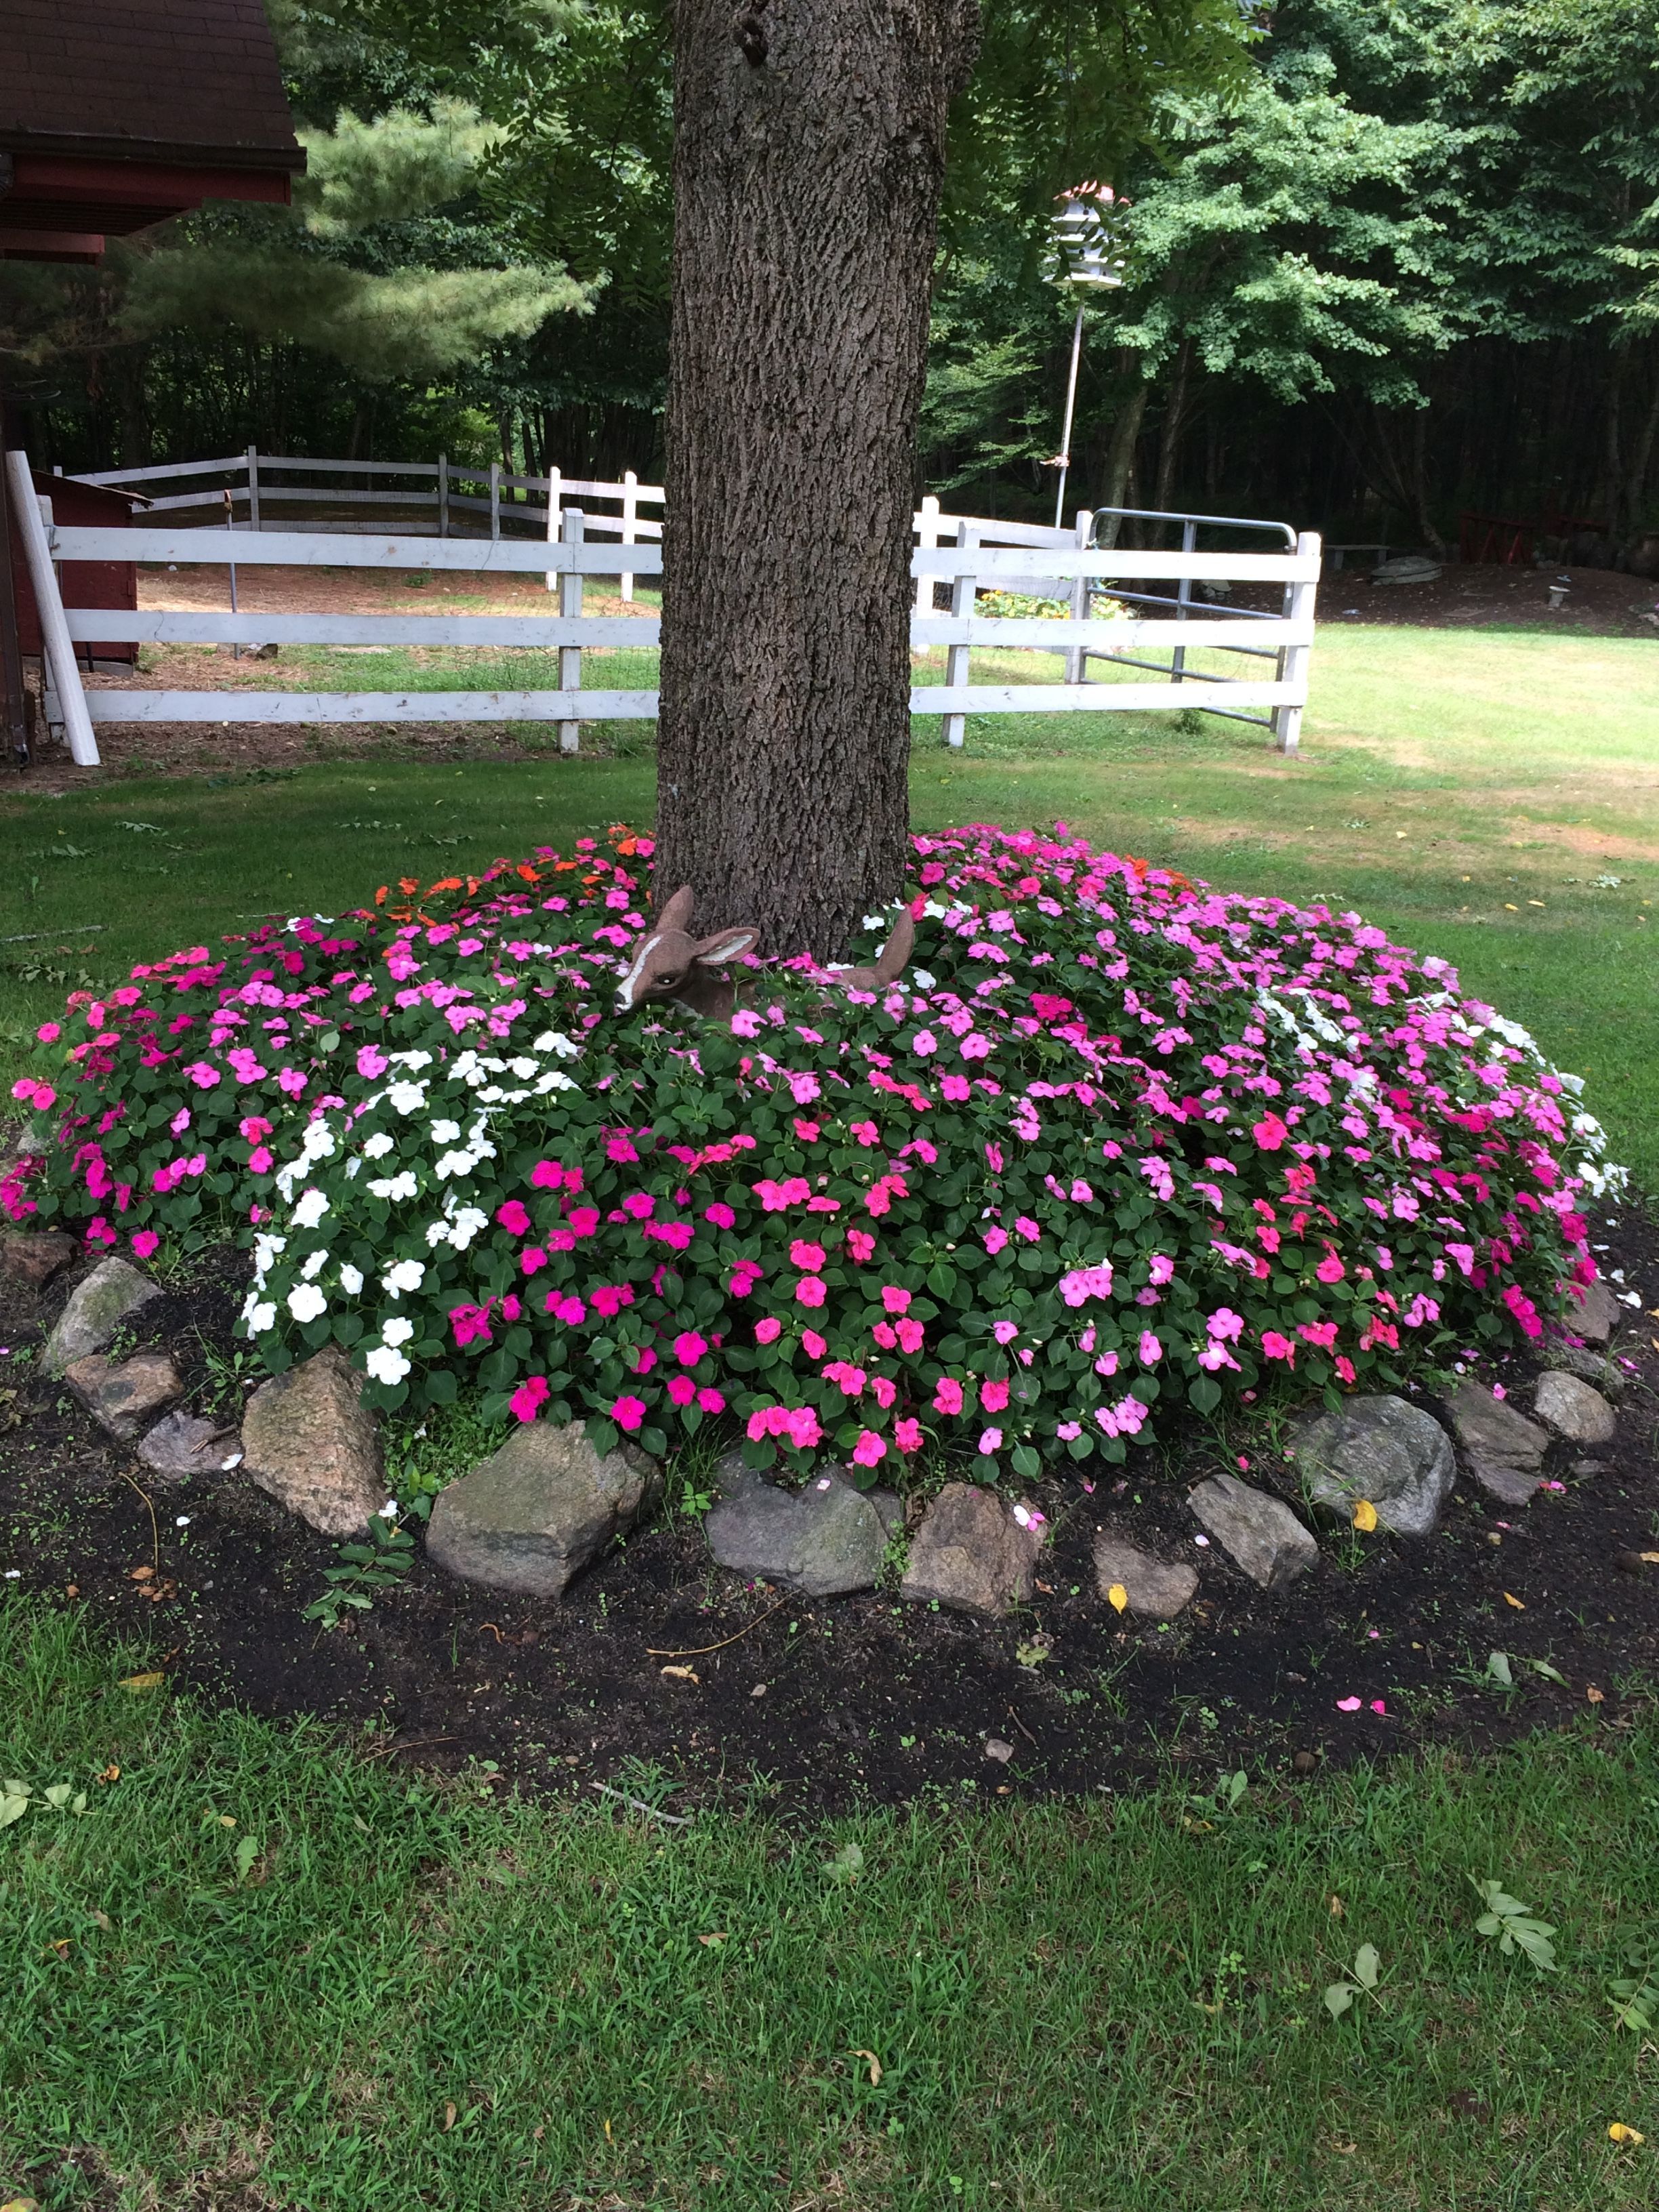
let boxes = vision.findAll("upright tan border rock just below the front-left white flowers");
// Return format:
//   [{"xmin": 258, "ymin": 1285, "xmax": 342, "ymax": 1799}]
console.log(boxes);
[{"xmin": 241, "ymin": 1345, "xmax": 385, "ymax": 1535}]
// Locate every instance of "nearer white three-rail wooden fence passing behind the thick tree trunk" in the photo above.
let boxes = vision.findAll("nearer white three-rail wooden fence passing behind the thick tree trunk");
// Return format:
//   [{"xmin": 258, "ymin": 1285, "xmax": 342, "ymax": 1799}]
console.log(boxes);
[{"xmin": 9, "ymin": 453, "xmax": 1321, "ymax": 765}]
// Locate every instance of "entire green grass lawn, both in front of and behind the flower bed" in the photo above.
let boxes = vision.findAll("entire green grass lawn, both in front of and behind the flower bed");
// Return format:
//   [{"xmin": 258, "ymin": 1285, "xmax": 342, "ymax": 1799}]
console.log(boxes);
[{"xmin": 0, "ymin": 628, "xmax": 1659, "ymax": 2212}]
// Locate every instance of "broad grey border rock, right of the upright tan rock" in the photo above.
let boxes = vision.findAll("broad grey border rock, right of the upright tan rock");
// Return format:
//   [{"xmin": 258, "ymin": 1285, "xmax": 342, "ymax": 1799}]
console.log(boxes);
[{"xmin": 427, "ymin": 1420, "xmax": 661, "ymax": 1597}]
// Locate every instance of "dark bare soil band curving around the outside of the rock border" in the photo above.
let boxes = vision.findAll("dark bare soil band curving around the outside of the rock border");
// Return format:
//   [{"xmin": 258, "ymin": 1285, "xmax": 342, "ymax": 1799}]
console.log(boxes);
[{"xmin": 0, "ymin": 1208, "xmax": 1659, "ymax": 1809}]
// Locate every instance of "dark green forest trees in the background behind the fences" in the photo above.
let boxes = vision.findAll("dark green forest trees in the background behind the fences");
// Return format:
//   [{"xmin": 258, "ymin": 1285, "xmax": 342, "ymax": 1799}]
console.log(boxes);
[{"xmin": 0, "ymin": 0, "xmax": 1659, "ymax": 571}]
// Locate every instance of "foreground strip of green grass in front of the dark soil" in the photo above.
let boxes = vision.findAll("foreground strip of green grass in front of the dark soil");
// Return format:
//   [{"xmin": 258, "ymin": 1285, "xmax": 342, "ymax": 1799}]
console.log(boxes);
[{"xmin": 0, "ymin": 1601, "xmax": 1659, "ymax": 2212}]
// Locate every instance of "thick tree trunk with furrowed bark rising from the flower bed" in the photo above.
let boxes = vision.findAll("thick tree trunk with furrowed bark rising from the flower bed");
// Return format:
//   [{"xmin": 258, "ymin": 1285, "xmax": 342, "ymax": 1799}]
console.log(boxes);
[{"xmin": 657, "ymin": 0, "xmax": 978, "ymax": 958}]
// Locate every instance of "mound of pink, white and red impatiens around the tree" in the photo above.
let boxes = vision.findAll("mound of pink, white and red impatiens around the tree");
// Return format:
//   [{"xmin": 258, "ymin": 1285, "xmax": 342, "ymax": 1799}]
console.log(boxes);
[{"xmin": 0, "ymin": 825, "xmax": 1617, "ymax": 1482}]
